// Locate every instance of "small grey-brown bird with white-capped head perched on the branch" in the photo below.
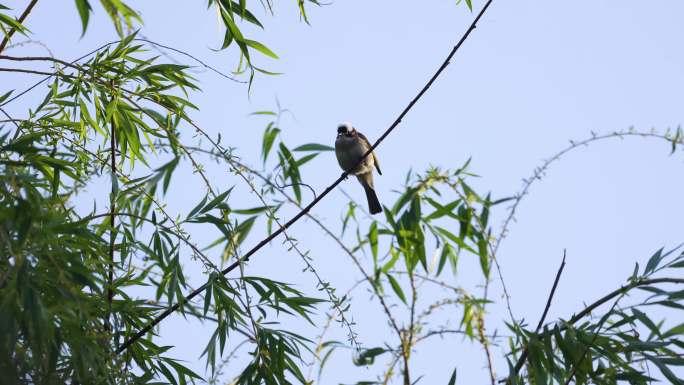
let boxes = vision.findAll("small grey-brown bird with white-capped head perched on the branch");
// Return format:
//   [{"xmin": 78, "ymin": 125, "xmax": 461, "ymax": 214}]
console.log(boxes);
[{"xmin": 335, "ymin": 123, "xmax": 382, "ymax": 214}]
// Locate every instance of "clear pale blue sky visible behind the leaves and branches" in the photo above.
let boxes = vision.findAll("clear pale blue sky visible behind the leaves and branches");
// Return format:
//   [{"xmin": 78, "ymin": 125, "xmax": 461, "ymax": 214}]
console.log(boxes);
[{"xmin": 0, "ymin": 0, "xmax": 684, "ymax": 384}]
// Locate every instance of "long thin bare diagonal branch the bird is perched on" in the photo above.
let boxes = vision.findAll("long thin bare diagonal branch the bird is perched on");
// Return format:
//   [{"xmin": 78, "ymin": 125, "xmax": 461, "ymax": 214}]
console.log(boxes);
[{"xmin": 117, "ymin": 0, "xmax": 493, "ymax": 353}]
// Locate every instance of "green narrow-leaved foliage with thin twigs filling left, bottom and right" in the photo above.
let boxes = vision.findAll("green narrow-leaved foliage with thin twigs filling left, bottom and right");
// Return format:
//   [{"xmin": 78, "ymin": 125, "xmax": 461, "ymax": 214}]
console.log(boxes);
[{"xmin": 0, "ymin": 0, "xmax": 684, "ymax": 384}]
